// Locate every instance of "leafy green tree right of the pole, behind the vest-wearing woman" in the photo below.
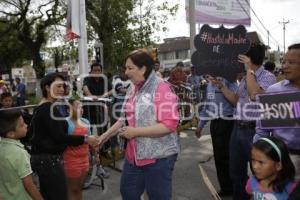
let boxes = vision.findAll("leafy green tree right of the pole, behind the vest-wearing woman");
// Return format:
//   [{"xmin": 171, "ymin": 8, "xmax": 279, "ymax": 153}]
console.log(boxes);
[{"xmin": 86, "ymin": 0, "xmax": 178, "ymax": 71}]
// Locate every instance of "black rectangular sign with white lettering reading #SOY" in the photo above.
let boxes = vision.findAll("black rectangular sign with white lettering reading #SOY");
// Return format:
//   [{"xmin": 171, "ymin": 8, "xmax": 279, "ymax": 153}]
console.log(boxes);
[{"xmin": 258, "ymin": 92, "xmax": 300, "ymax": 130}]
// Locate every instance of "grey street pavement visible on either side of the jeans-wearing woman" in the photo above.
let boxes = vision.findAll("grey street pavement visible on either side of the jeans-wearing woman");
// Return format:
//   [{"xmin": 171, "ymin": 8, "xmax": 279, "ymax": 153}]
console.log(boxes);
[{"xmin": 84, "ymin": 126, "xmax": 230, "ymax": 200}]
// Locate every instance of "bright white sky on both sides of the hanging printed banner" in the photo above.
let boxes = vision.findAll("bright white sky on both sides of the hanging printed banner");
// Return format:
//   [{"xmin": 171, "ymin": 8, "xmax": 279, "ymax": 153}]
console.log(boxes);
[{"xmin": 157, "ymin": 0, "xmax": 300, "ymax": 51}]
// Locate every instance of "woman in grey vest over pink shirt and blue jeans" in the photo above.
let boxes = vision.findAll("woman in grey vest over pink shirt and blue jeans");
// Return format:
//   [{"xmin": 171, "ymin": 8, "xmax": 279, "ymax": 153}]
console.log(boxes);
[{"xmin": 100, "ymin": 49, "xmax": 179, "ymax": 200}]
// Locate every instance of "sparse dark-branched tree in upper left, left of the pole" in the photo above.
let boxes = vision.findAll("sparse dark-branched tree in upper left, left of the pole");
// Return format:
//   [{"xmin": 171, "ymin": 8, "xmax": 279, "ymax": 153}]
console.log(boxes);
[{"xmin": 0, "ymin": 0, "xmax": 65, "ymax": 77}]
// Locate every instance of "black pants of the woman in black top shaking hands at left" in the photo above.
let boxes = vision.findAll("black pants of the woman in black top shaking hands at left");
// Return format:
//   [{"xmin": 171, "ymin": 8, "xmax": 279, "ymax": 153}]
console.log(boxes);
[{"xmin": 31, "ymin": 155, "xmax": 68, "ymax": 200}]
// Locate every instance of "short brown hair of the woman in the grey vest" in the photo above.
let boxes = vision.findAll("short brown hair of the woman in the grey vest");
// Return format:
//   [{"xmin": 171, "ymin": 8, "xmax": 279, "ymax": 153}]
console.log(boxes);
[{"xmin": 125, "ymin": 49, "xmax": 154, "ymax": 79}]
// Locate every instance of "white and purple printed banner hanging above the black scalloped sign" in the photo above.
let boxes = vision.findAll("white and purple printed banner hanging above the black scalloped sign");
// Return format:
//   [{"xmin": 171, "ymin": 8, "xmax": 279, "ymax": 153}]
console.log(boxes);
[{"xmin": 185, "ymin": 0, "xmax": 251, "ymax": 26}]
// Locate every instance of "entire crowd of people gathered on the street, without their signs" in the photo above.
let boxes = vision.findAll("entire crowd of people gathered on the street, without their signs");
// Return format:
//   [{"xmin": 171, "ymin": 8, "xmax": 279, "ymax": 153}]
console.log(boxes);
[{"xmin": 0, "ymin": 44, "xmax": 300, "ymax": 200}]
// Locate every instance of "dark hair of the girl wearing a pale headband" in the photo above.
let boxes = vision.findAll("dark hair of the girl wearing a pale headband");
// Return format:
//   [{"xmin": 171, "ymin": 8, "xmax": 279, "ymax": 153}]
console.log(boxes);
[{"xmin": 252, "ymin": 137, "xmax": 295, "ymax": 192}]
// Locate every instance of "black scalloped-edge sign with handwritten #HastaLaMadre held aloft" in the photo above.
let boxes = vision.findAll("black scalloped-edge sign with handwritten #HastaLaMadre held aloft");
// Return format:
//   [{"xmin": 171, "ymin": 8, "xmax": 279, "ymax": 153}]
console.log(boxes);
[{"xmin": 191, "ymin": 24, "xmax": 250, "ymax": 82}]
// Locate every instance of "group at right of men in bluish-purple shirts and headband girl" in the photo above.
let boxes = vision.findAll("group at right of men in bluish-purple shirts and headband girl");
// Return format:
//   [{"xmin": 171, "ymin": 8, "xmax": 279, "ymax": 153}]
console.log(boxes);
[{"xmin": 195, "ymin": 44, "xmax": 300, "ymax": 200}]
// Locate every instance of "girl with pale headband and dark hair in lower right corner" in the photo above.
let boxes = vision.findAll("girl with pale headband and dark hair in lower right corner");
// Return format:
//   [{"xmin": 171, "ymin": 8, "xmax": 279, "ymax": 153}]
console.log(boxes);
[{"xmin": 246, "ymin": 137, "xmax": 295, "ymax": 200}]
